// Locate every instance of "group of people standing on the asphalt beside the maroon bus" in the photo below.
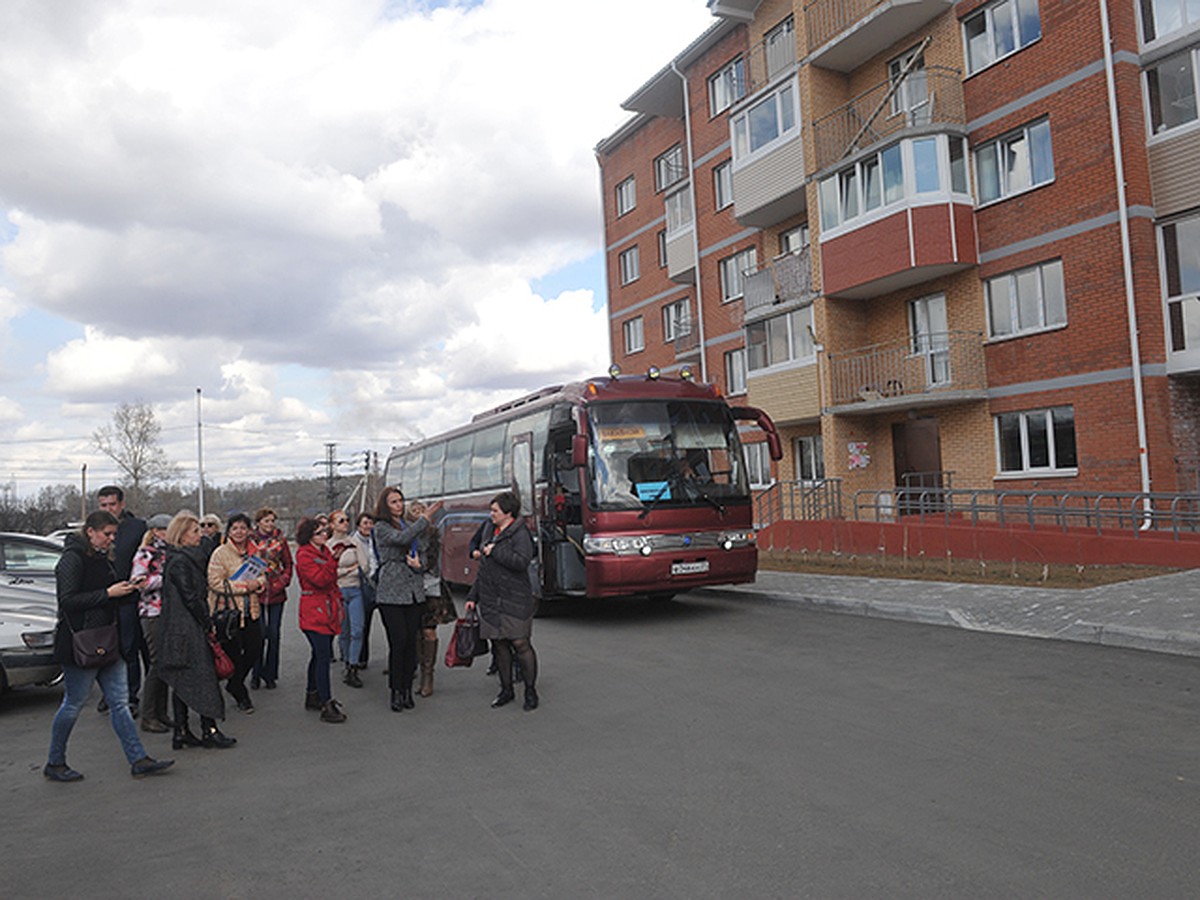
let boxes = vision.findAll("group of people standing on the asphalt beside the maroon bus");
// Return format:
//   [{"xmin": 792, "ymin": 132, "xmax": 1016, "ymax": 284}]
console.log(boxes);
[{"xmin": 43, "ymin": 487, "xmax": 539, "ymax": 781}]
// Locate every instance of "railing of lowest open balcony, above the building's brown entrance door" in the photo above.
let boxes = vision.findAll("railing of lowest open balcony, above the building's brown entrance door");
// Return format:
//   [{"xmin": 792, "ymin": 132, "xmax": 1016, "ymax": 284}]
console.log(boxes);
[{"xmin": 829, "ymin": 331, "xmax": 988, "ymax": 407}]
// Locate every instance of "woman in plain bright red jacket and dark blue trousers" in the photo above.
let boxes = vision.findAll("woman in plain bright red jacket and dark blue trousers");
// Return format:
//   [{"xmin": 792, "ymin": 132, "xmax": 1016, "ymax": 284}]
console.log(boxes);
[{"xmin": 295, "ymin": 518, "xmax": 346, "ymax": 724}]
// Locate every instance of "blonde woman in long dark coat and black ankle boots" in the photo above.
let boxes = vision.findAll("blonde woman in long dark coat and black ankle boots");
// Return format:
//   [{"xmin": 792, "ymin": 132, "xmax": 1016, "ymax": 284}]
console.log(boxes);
[{"xmin": 158, "ymin": 512, "xmax": 238, "ymax": 750}]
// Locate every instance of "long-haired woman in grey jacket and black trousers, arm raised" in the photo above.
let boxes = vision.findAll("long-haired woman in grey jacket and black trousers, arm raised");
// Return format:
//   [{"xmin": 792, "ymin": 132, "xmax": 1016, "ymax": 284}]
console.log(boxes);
[{"xmin": 372, "ymin": 487, "xmax": 442, "ymax": 713}]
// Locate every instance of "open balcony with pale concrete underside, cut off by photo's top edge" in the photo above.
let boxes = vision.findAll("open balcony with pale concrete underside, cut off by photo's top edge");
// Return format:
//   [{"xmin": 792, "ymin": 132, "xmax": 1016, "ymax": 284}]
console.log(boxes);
[{"xmin": 804, "ymin": 0, "xmax": 955, "ymax": 72}]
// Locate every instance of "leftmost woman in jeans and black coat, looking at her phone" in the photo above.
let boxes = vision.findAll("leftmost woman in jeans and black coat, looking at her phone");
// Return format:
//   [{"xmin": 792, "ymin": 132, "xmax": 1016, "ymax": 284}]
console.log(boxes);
[{"xmin": 42, "ymin": 510, "xmax": 173, "ymax": 781}]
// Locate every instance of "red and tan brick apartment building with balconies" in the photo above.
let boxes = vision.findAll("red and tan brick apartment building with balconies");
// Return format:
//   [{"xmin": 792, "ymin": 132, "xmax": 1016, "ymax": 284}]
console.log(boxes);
[{"xmin": 596, "ymin": 0, "xmax": 1200, "ymax": 513}]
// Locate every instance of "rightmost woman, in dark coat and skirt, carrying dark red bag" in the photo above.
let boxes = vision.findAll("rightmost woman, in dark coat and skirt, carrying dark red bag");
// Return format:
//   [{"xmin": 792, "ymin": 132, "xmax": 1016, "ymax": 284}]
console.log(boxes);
[{"xmin": 467, "ymin": 491, "xmax": 538, "ymax": 709}]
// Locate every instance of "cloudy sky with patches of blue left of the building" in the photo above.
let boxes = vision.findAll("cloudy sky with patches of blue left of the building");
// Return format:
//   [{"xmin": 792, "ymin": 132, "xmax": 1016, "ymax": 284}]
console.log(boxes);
[{"xmin": 0, "ymin": 0, "xmax": 713, "ymax": 497}]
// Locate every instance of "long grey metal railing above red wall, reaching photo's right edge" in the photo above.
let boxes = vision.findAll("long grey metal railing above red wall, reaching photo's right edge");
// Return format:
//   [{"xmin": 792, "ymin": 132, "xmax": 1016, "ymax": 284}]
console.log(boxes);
[{"xmin": 853, "ymin": 487, "xmax": 1200, "ymax": 539}]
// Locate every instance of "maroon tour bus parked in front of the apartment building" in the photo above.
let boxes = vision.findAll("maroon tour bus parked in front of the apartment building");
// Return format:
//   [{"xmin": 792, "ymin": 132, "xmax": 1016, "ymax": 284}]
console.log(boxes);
[{"xmin": 385, "ymin": 368, "xmax": 781, "ymax": 600}]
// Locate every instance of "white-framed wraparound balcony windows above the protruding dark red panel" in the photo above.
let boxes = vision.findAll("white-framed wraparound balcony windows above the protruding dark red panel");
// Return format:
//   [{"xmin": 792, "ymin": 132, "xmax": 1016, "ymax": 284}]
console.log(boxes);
[{"xmin": 818, "ymin": 134, "xmax": 967, "ymax": 230}]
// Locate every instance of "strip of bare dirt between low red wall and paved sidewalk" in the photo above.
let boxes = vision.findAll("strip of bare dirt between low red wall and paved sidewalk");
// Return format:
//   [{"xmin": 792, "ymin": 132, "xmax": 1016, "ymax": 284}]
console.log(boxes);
[{"xmin": 758, "ymin": 550, "xmax": 1183, "ymax": 588}]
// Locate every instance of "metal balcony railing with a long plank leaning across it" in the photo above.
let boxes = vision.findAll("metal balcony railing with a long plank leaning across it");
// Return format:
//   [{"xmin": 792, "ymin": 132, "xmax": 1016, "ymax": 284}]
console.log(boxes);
[{"xmin": 812, "ymin": 66, "xmax": 966, "ymax": 169}]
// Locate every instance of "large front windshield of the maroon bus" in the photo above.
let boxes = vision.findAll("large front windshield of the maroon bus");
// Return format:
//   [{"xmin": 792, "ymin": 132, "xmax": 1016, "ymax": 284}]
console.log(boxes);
[{"xmin": 588, "ymin": 400, "xmax": 750, "ymax": 510}]
